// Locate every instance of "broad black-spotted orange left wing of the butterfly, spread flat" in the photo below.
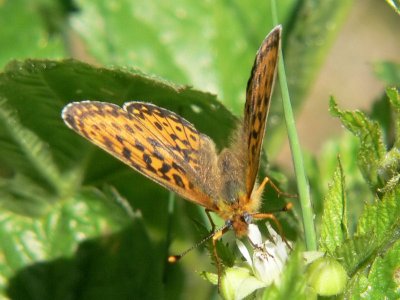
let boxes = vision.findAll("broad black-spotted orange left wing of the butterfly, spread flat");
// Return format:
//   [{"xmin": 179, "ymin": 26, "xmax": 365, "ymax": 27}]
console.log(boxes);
[{"xmin": 63, "ymin": 101, "xmax": 212, "ymax": 209}]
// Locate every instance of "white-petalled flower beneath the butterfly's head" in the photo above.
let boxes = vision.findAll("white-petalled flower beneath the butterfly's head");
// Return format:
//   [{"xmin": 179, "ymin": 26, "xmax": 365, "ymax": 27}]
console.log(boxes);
[{"xmin": 236, "ymin": 223, "xmax": 290, "ymax": 286}]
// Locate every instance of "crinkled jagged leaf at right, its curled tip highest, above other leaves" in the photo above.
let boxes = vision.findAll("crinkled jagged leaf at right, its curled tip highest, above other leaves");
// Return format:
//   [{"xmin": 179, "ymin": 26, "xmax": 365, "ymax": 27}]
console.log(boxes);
[{"xmin": 330, "ymin": 98, "xmax": 386, "ymax": 192}]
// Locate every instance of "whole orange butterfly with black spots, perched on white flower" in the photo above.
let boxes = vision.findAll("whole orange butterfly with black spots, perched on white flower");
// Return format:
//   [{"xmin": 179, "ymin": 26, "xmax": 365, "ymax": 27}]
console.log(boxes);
[{"xmin": 62, "ymin": 25, "xmax": 282, "ymax": 286}]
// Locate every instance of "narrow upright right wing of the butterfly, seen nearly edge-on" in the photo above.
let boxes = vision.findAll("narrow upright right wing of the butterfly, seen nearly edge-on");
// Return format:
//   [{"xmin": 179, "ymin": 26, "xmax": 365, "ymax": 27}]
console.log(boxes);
[{"xmin": 244, "ymin": 26, "xmax": 281, "ymax": 199}]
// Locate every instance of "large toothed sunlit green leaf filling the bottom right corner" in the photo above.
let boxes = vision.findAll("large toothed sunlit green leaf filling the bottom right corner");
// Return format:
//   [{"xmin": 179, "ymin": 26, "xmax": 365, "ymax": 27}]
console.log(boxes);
[{"xmin": 336, "ymin": 185, "xmax": 400, "ymax": 298}]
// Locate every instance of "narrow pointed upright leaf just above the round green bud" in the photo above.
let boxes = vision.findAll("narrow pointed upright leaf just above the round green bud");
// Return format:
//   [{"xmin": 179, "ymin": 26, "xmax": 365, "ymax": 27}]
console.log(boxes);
[{"xmin": 320, "ymin": 159, "xmax": 348, "ymax": 253}]
